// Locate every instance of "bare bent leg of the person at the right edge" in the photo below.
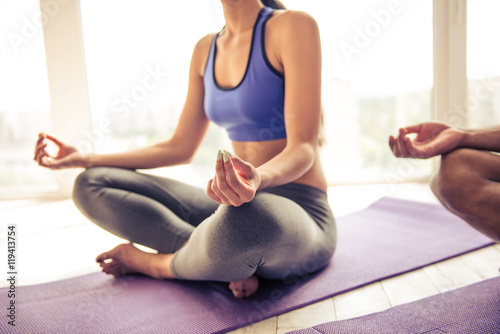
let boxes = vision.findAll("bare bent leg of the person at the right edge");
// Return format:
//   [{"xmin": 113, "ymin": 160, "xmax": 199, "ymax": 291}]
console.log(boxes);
[{"xmin": 431, "ymin": 149, "xmax": 500, "ymax": 242}]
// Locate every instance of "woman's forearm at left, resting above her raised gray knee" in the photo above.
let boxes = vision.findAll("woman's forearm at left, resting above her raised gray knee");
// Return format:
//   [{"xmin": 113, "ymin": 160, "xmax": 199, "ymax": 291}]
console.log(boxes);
[{"xmin": 84, "ymin": 141, "xmax": 191, "ymax": 169}]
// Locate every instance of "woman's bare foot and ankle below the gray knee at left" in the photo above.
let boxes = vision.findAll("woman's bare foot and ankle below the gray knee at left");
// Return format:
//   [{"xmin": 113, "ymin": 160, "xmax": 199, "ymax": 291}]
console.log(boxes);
[{"xmin": 96, "ymin": 244, "xmax": 175, "ymax": 279}]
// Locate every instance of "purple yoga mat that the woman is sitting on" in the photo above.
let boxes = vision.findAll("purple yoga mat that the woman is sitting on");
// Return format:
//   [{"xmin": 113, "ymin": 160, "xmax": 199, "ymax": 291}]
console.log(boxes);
[{"xmin": 0, "ymin": 198, "xmax": 492, "ymax": 334}]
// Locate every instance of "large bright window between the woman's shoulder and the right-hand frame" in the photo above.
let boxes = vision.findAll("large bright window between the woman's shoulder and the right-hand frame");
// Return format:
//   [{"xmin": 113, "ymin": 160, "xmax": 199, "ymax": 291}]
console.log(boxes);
[{"xmin": 285, "ymin": 0, "xmax": 433, "ymax": 184}]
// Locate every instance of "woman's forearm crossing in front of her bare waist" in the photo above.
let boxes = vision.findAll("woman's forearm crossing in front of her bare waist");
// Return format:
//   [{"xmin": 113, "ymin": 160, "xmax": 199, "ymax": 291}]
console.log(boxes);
[{"xmin": 257, "ymin": 143, "xmax": 316, "ymax": 189}]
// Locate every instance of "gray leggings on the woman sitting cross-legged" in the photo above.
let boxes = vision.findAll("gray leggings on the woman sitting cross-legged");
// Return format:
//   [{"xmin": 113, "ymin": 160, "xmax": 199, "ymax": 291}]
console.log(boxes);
[{"xmin": 73, "ymin": 167, "xmax": 336, "ymax": 282}]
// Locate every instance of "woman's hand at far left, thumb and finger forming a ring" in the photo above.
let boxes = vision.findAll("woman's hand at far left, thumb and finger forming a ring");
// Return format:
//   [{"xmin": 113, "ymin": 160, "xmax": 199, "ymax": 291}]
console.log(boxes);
[{"xmin": 33, "ymin": 133, "xmax": 85, "ymax": 169}]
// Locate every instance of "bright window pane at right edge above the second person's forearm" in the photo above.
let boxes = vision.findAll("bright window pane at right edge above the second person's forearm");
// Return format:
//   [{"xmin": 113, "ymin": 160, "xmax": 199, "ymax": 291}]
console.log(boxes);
[{"xmin": 464, "ymin": 0, "xmax": 500, "ymax": 128}]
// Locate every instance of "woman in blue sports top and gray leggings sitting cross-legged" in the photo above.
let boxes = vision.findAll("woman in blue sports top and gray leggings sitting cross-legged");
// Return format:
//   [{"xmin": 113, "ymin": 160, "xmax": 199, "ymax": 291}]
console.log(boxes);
[{"xmin": 35, "ymin": 0, "xmax": 336, "ymax": 298}]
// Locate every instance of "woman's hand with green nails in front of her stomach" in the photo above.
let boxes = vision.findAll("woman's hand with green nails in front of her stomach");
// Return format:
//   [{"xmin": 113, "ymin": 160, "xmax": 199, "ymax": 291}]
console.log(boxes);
[{"xmin": 207, "ymin": 150, "xmax": 261, "ymax": 206}]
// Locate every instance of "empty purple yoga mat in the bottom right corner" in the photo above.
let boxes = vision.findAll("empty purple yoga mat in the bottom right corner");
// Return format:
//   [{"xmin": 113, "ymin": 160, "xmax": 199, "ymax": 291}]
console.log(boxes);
[{"xmin": 289, "ymin": 277, "xmax": 500, "ymax": 334}]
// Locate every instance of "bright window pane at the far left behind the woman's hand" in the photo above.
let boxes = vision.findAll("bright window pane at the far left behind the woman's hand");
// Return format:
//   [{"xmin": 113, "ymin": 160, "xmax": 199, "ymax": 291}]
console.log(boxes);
[{"xmin": 0, "ymin": 0, "xmax": 57, "ymax": 197}]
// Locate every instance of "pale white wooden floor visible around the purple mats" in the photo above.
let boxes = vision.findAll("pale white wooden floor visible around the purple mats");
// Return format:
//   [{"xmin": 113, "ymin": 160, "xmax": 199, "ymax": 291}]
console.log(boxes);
[{"xmin": 0, "ymin": 184, "xmax": 500, "ymax": 334}]
